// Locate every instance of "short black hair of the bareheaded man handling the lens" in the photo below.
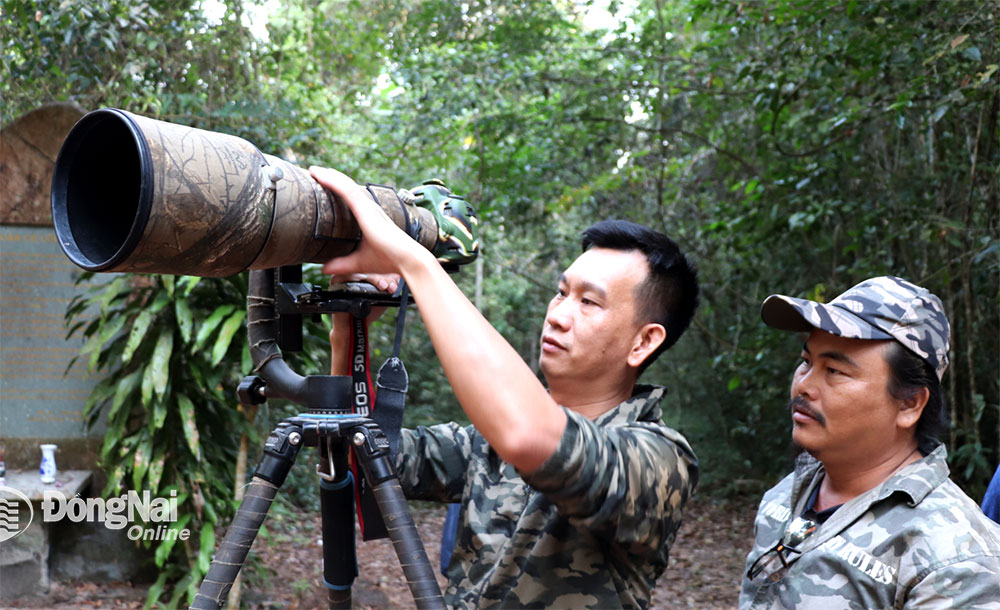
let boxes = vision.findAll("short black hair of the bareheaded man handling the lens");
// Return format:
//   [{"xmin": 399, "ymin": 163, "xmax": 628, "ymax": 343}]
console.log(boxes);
[{"xmin": 583, "ymin": 219, "xmax": 698, "ymax": 373}]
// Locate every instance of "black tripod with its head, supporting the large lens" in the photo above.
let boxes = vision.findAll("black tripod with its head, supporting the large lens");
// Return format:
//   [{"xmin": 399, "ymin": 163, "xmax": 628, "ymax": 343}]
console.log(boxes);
[{"xmin": 190, "ymin": 266, "xmax": 444, "ymax": 610}]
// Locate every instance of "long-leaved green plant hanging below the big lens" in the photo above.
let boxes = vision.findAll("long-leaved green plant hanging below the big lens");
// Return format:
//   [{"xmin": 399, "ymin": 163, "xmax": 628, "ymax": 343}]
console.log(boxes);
[{"xmin": 66, "ymin": 274, "xmax": 256, "ymax": 607}]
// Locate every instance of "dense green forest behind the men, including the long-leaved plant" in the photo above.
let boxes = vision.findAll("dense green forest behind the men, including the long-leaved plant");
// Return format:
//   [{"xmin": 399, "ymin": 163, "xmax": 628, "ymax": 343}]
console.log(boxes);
[{"xmin": 0, "ymin": 0, "xmax": 1000, "ymax": 595}]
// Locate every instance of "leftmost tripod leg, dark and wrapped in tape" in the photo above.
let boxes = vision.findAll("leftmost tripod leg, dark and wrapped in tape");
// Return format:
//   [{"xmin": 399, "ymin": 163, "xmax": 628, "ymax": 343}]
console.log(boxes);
[{"xmin": 190, "ymin": 422, "xmax": 302, "ymax": 610}]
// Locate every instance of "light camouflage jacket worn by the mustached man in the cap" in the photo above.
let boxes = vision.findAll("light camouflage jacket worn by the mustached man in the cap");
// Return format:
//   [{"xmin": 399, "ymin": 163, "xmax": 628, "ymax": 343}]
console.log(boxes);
[{"xmin": 740, "ymin": 445, "xmax": 1000, "ymax": 610}]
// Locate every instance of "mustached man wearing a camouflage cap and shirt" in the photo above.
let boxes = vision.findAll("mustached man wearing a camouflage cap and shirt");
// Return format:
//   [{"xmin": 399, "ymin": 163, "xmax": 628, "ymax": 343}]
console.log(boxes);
[{"xmin": 740, "ymin": 277, "xmax": 1000, "ymax": 609}]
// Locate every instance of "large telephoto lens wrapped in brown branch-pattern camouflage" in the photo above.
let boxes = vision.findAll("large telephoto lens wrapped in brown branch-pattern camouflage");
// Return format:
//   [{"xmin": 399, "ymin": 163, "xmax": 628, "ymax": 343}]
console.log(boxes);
[{"xmin": 52, "ymin": 109, "xmax": 438, "ymax": 277}]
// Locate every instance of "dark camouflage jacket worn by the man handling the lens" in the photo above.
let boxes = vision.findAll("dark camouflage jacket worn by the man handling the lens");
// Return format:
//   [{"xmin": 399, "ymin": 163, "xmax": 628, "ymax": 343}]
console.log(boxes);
[{"xmin": 396, "ymin": 387, "xmax": 698, "ymax": 608}]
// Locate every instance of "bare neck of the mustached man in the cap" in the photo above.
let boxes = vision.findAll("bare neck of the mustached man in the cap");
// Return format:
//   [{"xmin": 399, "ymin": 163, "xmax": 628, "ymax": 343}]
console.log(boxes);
[{"xmin": 815, "ymin": 440, "xmax": 921, "ymax": 511}]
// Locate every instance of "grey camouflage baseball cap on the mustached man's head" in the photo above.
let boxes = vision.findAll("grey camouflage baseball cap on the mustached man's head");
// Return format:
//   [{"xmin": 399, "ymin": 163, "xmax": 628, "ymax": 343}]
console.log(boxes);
[{"xmin": 760, "ymin": 276, "xmax": 951, "ymax": 380}]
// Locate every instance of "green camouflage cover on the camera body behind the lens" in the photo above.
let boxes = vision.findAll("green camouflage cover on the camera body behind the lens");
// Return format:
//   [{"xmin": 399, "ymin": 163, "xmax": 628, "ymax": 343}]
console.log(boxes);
[{"xmin": 401, "ymin": 180, "xmax": 479, "ymax": 265}]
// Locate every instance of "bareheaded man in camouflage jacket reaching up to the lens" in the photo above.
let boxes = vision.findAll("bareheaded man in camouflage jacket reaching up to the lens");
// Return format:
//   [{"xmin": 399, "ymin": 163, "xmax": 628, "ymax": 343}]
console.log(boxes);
[{"xmin": 313, "ymin": 168, "xmax": 698, "ymax": 608}]
